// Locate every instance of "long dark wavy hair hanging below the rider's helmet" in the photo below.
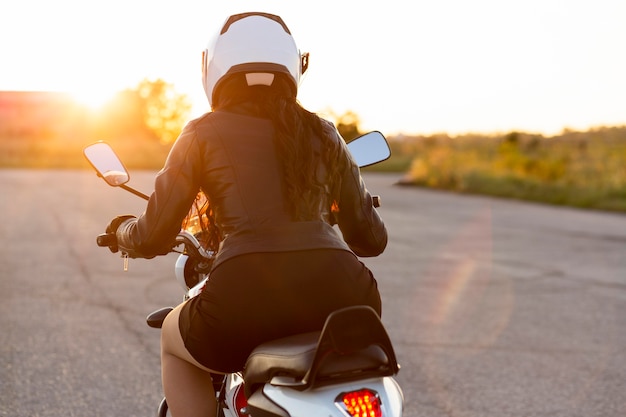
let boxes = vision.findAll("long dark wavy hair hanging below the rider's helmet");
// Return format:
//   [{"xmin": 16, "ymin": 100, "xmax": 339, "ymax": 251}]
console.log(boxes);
[{"xmin": 188, "ymin": 74, "xmax": 343, "ymax": 250}]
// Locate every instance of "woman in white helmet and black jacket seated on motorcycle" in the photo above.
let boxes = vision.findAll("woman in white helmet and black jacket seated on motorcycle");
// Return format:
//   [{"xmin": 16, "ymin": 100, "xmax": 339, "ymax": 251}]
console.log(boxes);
[{"xmin": 102, "ymin": 13, "xmax": 387, "ymax": 417}]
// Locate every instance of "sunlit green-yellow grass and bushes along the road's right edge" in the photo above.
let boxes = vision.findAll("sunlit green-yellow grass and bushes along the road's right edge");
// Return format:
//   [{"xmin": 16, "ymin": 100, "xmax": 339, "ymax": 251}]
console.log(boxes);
[{"xmin": 395, "ymin": 127, "xmax": 626, "ymax": 212}]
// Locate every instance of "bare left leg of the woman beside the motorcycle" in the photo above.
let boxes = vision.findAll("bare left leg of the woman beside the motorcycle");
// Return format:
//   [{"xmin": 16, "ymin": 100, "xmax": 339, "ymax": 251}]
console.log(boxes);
[{"xmin": 161, "ymin": 304, "xmax": 216, "ymax": 417}]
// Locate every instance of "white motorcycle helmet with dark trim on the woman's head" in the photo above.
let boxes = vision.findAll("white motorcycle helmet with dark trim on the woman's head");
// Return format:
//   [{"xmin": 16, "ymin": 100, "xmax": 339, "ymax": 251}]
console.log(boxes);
[{"xmin": 202, "ymin": 12, "xmax": 309, "ymax": 106}]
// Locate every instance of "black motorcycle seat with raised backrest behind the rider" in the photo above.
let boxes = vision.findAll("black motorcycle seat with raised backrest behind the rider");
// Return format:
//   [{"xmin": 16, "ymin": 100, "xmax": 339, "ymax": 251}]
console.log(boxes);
[{"xmin": 243, "ymin": 306, "xmax": 399, "ymax": 398}]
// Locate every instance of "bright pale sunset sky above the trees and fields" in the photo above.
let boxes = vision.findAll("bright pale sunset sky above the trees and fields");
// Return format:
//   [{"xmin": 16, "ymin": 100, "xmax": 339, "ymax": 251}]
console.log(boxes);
[{"xmin": 0, "ymin": 0, "xmax": 626, "ymax": 135}]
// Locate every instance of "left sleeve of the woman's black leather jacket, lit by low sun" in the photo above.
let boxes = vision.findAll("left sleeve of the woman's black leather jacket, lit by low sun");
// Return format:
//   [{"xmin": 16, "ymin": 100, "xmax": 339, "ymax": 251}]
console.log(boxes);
[{"xmin": 116, "ymin": 124, "xmax": 200, "ymax": 258}]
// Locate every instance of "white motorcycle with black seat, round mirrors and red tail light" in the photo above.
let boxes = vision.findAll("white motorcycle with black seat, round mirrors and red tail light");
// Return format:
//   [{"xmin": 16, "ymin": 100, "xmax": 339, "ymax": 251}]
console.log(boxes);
[{"xmin": 84, "ymin": 132, "xmax": 404, "ymax": 417}]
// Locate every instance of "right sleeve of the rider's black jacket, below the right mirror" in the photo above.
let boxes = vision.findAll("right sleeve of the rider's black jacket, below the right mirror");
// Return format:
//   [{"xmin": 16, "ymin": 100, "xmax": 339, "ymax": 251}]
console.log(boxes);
[{"xmin": 336, "ymin": 139, "xmax": 387, "ymax": 257}]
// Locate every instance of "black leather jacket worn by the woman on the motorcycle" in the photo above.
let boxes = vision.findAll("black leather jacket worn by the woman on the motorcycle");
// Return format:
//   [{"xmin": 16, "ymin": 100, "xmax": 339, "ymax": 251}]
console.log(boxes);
[{"xmin": 117, "ymin": 107, "xmax": 387, "ymax": 267}]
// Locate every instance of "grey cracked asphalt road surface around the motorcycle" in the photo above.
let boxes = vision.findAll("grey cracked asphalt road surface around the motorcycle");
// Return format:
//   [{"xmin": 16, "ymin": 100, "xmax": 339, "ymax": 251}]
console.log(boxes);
[{"xmin": 0, "ymin": 170, "xmax": 626, "ymax": 417}]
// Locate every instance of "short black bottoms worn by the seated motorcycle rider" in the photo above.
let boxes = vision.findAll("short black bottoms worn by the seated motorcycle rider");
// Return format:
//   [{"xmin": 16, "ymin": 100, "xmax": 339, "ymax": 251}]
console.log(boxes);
[{"xmin": 179, "ymin": 249, "xmax": 381, "ymax": 372}]
